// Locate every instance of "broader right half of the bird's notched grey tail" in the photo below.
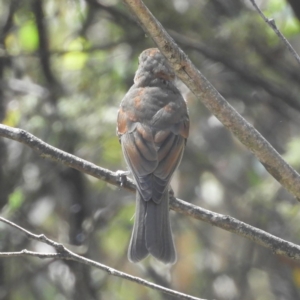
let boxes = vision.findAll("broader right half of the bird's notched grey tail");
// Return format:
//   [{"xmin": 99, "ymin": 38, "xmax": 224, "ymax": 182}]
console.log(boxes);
[{"xmin": 144, "ymin": 189, "xmax": 176, "ymax": 264}]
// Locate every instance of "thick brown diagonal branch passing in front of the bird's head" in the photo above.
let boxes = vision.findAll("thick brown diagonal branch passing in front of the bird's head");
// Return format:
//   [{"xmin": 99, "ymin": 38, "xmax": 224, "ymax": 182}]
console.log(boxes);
[{"xmin": 123, "ymin": 0, "xmax": 300, "ymax": 201}]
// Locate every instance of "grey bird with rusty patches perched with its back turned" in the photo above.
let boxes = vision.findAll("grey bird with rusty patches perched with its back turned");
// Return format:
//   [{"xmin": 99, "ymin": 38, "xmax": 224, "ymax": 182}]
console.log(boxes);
[{"xmin": 117, "ymin": 48, "xmax": 190, "ymax": 264}]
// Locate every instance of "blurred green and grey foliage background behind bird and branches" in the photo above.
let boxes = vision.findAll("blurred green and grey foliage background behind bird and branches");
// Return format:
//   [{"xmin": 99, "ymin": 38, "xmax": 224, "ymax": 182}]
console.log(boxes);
[{"xmin": 0, "ymin": 0, "xmax": 300, "ymax": 300}]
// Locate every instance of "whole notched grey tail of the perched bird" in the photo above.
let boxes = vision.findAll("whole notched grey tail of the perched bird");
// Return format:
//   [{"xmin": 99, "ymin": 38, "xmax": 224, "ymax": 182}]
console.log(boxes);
[{"xmin": 128, "ymin": 190, "xmax": 176, "ymax": 264}]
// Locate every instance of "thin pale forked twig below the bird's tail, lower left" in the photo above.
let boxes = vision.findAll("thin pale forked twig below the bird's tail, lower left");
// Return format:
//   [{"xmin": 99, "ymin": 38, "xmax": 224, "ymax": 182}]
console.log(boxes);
[{"xmin": 0, "ymin": 217, "xmax": 205, "ymax": 300}]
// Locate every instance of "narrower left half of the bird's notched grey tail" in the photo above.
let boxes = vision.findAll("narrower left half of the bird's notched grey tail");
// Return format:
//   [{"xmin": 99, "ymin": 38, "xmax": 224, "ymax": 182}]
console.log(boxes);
[{"xmin": 128, "ymin": 191, "xmax": 149, "ymax": 263}]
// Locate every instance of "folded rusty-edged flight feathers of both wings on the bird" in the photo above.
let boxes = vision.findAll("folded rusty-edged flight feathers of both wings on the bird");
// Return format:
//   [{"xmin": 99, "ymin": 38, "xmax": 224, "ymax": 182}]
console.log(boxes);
[{"xmin": 120, "ymin": 120, "xmax": 186, "ymax": 203}]
